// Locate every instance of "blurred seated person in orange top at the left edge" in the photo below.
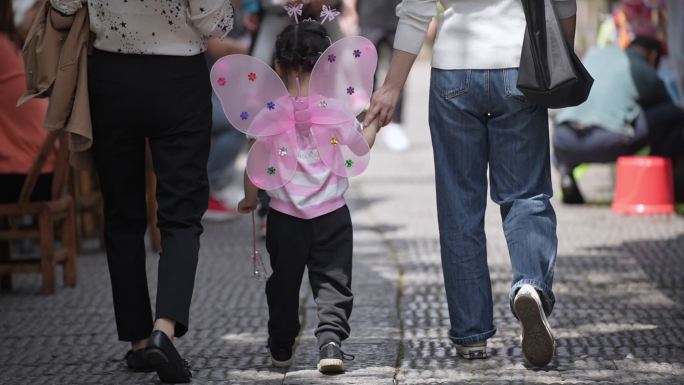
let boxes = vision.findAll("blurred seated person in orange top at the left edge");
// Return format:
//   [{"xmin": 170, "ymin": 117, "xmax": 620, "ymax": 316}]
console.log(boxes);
[{"xmin": 0, "ymin": 0, "xmax": 54, "ymax": 203}]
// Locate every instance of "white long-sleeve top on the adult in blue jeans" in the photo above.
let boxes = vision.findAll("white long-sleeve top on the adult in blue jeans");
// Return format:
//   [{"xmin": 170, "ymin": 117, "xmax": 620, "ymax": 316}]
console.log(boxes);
[{"xmin": 394, "ymin": 0, "xmax": 577, "ymax": 69}]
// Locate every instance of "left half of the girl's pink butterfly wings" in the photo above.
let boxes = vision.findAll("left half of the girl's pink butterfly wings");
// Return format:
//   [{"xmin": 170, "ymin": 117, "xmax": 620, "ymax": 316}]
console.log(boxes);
[{"xmin": 210, "ymin": 55, "xmax": 297, "ymax": 190}]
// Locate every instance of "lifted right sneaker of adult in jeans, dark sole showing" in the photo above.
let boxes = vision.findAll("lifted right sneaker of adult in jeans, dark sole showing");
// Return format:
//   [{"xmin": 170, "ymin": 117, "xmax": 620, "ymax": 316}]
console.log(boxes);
[{"xmin": 513, "ymin": 285, "xmax": 556, "ymax": 367}]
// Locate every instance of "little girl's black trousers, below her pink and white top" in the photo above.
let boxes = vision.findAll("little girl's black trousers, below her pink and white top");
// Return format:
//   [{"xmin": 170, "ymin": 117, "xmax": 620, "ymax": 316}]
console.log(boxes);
[{"xmin": 266, "ymin": 206, "xmax": 354, "ymax": 346}]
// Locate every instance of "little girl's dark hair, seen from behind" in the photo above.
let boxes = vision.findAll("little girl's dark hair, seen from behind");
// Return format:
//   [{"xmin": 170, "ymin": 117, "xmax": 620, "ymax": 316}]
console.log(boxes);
[{"xmin": 275, "ymin": 20, "xmax": 330, "ymax": 72}]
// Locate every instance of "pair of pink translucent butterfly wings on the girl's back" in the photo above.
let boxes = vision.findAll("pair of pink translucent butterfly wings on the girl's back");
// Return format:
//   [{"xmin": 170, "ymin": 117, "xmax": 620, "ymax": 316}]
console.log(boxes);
[{"xmin": 210, "ymin": 37, "xmax": 377, "ymax": 190}]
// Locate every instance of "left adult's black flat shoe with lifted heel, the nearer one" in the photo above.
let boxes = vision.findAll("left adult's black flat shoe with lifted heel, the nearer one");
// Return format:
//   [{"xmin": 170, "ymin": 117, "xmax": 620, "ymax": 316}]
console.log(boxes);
[{"xmin": 145, "ymin": 330, "xmax": 192, "ymax": 384}]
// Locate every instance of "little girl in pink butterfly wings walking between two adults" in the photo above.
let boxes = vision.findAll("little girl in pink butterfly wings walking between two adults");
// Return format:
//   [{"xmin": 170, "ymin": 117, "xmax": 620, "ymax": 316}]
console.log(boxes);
[{"xmin": 212, "ymin": 21, "xmax": 377, "ymax": 373}]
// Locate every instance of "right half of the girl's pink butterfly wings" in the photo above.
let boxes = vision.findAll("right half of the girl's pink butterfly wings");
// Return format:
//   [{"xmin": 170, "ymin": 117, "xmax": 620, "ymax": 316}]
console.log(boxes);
[{"xmin": 309, "ymin": 36, "xmax": 378, "ymax": 177}]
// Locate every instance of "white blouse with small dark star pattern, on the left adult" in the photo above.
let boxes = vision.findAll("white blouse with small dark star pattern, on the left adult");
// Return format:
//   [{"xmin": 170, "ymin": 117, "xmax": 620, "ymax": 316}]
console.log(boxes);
[{"xmin": 50, "ymin": 0, "xmax": 233, "ymax": 56}]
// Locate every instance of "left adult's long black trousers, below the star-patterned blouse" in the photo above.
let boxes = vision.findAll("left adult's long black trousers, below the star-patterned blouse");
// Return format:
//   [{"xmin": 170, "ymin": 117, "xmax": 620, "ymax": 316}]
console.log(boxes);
[{"xmin": 88, "ymin": 51, "xmax": 211, "ymax": 341}]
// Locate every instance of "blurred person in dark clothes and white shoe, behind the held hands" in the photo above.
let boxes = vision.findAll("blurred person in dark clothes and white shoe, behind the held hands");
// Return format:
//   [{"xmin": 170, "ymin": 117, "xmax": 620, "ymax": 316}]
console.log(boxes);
[{"xmin": 340, "ymin": 0, "xmax": 411, "ymax": 151}]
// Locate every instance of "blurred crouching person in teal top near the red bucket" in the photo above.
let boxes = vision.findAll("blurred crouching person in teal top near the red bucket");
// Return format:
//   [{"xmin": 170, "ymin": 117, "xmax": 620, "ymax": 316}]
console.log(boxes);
[{"xmin": 553, "ymin": 36, "xmax": 684, "ymax": 203}]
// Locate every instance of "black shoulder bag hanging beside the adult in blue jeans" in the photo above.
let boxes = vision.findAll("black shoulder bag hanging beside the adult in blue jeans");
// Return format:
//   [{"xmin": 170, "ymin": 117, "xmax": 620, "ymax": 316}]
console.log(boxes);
[{"xmin": 517, "ymin": 0, "xmax": 594, "ymax": 108}]
